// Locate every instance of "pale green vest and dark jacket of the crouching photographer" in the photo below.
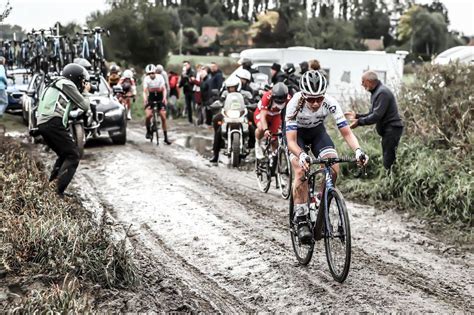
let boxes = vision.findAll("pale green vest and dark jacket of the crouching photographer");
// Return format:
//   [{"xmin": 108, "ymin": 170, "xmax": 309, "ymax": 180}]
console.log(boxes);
[{"xmin": 36, "ymin": 78, "xmax": 90, "ymax": 127}]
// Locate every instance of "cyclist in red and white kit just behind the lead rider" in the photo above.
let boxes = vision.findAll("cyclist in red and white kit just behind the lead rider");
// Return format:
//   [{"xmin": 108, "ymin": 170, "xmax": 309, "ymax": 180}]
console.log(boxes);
[{"xmin": 254, "ymin": 82, "xmax": 291, "ymax": 160}]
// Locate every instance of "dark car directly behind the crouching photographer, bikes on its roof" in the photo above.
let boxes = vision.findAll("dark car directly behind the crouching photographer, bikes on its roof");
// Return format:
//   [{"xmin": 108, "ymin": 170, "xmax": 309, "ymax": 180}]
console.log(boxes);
[{"xmin": 22, "ymin": 73, "xmax": 127, "ymax": 144}]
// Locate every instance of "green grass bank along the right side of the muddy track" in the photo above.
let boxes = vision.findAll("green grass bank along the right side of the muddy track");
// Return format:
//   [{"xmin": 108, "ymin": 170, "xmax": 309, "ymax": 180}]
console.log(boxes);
[{"xmin": 330, "ymin": 127, "xmax": 474, "ymax": 226}]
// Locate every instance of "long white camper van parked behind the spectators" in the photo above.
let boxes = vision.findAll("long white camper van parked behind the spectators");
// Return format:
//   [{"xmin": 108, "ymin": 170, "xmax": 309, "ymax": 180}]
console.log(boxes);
[{"xmin": 240, "ymin": 47, "xmax": 408, "ymax": 104}]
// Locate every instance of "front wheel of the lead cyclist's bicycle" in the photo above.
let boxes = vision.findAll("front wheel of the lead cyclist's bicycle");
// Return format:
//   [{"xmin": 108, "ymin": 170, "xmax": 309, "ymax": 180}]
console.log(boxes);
[{"xmin": 324, "ymin": 189, "xmax": 351, "ymax": 283}]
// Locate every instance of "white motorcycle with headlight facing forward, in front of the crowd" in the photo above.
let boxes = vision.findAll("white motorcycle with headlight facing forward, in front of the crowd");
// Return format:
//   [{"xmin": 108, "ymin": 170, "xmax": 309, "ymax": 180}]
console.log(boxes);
[{"xmin": 211, "ymin": 92, "xmax": 256, "ymax": 167}]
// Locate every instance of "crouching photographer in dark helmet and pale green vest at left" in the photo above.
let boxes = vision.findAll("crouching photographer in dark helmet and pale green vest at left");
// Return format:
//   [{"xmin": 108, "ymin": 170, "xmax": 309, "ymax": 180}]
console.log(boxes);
[{"xmin": 36, "ymin": 63, "xmax": 90, "ymax": 197}]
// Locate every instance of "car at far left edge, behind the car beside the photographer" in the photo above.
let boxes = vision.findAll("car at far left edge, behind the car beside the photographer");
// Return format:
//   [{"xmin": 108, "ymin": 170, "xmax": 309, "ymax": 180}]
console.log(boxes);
[{"xmin": 7, "ymin": 69, "xmax": 31, "ymax": 113}]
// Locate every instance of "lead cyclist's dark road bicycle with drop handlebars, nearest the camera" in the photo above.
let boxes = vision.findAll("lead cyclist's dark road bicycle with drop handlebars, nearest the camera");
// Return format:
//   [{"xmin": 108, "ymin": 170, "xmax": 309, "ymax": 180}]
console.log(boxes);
[{"xmin": 289, "ymin": 157, "xmax": 362, "ymax": 283}]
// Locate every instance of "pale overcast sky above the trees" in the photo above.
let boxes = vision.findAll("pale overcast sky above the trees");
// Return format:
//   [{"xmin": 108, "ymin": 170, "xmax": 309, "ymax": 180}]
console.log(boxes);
[{"xmin": 0, "ymin": 0, "xmax": 474, "ymax": 36}]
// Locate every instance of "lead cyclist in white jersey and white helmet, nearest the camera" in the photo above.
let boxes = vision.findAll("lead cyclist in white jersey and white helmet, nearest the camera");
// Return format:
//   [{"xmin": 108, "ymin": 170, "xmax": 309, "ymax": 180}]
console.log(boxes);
[{"xmin": 286, "ymin": 70, "xmax": 369, "ymax": 243}]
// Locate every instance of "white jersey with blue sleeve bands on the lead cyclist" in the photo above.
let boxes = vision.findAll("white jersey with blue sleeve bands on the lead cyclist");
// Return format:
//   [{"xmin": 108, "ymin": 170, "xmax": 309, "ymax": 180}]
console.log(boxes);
[{"xmin": 285, "ymin": 92, "xmax": 348, "ymax": 131}]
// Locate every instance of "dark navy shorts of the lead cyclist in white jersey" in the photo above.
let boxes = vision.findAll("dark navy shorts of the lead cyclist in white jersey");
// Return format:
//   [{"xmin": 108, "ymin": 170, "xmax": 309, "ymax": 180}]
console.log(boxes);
[{"xmin": 290, "ymin": 124, "xmax": 337, "ymax": 159}]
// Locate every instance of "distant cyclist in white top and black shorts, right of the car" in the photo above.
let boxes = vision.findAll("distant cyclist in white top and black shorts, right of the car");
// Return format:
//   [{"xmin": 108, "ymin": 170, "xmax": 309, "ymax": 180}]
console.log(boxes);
[{"xmin": 143, "ymin": 64, "xmax": 171, "ymax": 144}]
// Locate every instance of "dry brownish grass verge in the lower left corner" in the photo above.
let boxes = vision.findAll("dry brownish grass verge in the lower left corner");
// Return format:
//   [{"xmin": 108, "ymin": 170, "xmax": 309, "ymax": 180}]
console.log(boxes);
[{"xmin": 0, "ymin": 137, "xmax": 139, "ymax": 313}]
